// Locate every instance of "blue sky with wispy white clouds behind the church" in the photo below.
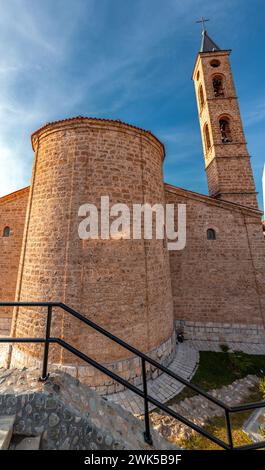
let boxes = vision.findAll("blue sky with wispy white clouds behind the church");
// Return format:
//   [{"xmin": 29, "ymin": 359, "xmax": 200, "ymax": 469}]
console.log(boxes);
[{"xmin": 0, "ymin": 0, "xmax": 265, "ymax": 207}]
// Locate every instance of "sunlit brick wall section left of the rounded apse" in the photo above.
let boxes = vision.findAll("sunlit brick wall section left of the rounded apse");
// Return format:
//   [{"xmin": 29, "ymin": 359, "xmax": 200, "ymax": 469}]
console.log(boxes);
[{"xmin": 0, "ymin": 188, "xmax": 29, "ymax": 335}]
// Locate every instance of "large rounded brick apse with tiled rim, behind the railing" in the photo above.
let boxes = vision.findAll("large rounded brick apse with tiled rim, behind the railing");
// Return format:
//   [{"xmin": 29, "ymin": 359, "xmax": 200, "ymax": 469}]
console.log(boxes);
[{"xmin": 10, "ymin": 119, "xmax": 175, "ymax": 382}]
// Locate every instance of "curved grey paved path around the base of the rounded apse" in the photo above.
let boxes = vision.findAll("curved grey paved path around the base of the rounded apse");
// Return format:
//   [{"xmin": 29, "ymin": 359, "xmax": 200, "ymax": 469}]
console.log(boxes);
[{"xmin": 106, "ymin": 341, "xmax": 199, "ymax": 415}]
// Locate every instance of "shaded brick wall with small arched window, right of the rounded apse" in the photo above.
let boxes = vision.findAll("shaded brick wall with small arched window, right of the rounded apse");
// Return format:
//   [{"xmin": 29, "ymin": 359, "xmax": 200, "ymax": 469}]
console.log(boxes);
[{"xmin": 165, "ymin": 185, "xmax": 265, "ymax": 342}]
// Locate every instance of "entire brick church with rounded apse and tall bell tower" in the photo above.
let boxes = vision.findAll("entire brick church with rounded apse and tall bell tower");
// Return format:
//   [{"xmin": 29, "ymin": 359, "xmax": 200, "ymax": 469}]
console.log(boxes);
[{"xmin": 0, "ymin": 30, "xmax": 265, "ymax": 393}]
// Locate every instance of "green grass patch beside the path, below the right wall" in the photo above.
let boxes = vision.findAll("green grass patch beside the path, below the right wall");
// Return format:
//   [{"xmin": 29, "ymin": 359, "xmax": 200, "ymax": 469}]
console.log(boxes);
[{"xmin": 168, "ymin": 351, "xmax": 265, "ymax": 405}]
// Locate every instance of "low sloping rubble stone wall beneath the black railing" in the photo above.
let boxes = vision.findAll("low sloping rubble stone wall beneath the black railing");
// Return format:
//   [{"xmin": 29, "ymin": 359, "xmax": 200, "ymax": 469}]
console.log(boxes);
[{"xmin": 0, "ymin": 368, "xmax": 177, "ymax": 451}]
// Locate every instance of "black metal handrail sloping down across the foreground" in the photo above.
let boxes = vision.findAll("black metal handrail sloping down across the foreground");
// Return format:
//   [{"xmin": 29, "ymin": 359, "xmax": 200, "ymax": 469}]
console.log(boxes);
[{"xmin": 0, "ymin": 302, "xmax": 265, "ymax": 450}]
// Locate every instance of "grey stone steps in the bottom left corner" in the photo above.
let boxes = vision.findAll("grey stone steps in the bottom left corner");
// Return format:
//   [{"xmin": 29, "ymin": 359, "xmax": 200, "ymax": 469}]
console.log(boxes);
[{"xmin": 0, "ymin": 416, "xmax": 41, "ymax": 450}]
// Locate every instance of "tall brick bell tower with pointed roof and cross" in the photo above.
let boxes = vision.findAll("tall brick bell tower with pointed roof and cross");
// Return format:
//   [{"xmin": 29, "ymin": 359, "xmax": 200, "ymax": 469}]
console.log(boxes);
[{"xmin": 192, "ymin": 26, "xmax": 258, "ymax": 209}]
